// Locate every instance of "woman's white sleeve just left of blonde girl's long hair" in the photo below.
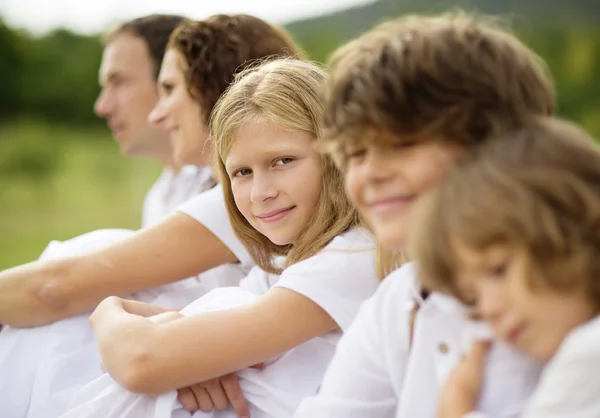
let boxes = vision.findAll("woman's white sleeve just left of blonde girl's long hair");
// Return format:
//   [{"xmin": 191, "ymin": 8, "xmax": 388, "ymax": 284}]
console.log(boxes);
[{"xmin": 177, "ymin": 185, "xmax": 253, "ymax": 264}]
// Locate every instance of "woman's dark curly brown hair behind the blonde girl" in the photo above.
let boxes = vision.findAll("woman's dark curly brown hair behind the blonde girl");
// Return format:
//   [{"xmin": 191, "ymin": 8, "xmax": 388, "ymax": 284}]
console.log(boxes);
[{"xmin": 167, "ymin": 14, "xmax": 305, "ymax": 123}]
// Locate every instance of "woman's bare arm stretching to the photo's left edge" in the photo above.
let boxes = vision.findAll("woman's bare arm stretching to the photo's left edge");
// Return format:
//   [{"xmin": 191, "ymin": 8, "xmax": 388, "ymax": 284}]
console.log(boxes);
[{"xmin": 0, "ymin": 213, "xmax": 237, "ymax": 327}]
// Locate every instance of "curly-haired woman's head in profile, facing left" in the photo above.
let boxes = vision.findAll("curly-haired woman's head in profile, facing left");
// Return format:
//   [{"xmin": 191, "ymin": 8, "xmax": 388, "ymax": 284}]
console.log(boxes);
[{"xmin": 150, "ymin": 15, "xmax": 303, "ymax": 165}]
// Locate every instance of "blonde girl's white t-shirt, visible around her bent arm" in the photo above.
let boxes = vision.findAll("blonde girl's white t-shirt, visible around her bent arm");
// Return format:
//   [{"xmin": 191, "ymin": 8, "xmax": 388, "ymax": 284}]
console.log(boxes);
[{"xmin": 63, "ymin": 229, "xmax": 379, "ymax": 418}]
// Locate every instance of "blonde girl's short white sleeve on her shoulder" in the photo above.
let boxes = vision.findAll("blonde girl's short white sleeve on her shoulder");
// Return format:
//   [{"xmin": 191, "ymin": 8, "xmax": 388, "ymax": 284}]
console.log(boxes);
[{"xmin": 275, "ymin": 230, "xmax": 380, "ymax": 330}]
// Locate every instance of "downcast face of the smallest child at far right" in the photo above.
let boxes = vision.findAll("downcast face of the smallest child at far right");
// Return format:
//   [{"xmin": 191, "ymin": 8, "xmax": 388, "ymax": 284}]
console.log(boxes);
[{"xmin": 454, "ymin": 241, "xmax": 597, "ymax": 362}]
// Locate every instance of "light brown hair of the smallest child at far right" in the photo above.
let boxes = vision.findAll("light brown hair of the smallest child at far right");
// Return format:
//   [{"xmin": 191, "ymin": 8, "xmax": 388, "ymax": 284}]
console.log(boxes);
[{"xmin": 409, "ymin": 118, "xmax": 600, "ymax": 307}]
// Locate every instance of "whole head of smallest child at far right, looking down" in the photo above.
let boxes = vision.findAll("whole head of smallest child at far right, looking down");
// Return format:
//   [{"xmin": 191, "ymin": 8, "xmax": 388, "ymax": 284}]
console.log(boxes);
[{"xmin": 410, "ymin": 119, "xmax": 600, "ymax": 360}]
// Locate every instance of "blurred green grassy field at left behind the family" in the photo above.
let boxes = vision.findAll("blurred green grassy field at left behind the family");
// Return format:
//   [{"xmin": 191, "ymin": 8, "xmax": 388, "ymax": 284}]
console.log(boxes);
[{"xmin": 0, "ymin": 122, "xmax": 160, "ymax": 270}]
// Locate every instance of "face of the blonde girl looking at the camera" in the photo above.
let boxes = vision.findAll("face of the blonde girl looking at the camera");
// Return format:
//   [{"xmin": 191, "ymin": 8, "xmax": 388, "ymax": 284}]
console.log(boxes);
[{"xmin": 225, "ymin": 120, "xmax": 323, "ymax": 245}]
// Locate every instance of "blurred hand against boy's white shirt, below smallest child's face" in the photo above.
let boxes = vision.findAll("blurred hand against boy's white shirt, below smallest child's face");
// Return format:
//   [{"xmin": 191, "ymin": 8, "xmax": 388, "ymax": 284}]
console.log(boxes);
[{"xmin": 438, "ymin": 341, "xmax": 491, "ymax": 418}]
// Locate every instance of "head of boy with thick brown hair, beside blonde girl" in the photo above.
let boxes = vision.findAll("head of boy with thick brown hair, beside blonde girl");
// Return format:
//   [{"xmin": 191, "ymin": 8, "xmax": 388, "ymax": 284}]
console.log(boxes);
[{"xmin": 324, "ymin": 14, "xmax": 555, "ymax": 248}]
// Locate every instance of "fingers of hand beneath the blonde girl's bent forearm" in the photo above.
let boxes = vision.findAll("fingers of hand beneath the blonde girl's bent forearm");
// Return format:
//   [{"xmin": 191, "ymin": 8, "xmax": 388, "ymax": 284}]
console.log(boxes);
[{"xmin": 177, "ymin": 373, "xmax": 250, "ymax": 418}]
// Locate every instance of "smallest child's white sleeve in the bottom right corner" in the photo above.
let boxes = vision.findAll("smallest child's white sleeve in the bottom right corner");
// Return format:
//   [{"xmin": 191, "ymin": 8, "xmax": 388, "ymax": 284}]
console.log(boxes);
[{"xmin": 524, "ymin": 319, "xmax": 600, "ymax": 418}]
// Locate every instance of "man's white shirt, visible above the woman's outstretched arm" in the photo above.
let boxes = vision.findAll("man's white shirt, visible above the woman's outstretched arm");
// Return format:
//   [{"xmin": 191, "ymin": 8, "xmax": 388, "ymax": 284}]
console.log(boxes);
[{"xmin": 142, "ymin": 165, "xmax": 215, "ymax": 227}]
